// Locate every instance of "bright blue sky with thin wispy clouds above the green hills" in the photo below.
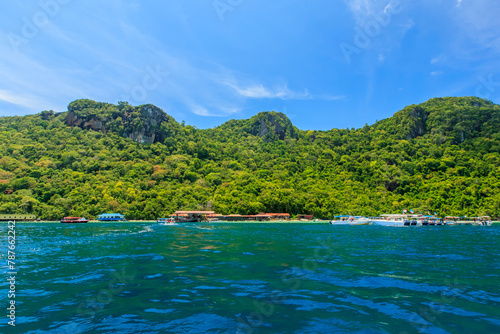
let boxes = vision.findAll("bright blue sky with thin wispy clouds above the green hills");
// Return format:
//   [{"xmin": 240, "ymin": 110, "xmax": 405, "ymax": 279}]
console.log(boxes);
[{"xmin": 0, "ymin": 0, "xmax": 500, "ymax": 130}]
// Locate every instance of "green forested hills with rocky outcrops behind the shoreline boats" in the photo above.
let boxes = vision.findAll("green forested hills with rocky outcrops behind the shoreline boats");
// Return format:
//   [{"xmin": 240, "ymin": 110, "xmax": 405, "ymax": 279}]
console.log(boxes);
[{"xmin": 0, "ymin": 97, "xmax": 500, "ymax": 219}]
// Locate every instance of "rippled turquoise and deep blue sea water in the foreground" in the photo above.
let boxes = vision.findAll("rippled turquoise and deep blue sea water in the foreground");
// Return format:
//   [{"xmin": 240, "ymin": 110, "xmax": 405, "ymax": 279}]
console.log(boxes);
[{"xmin": 0, "ymin": 223, "xmax": 500, "ymax": 334}]
